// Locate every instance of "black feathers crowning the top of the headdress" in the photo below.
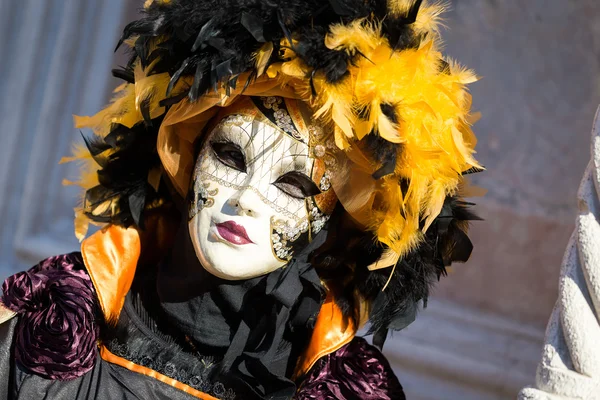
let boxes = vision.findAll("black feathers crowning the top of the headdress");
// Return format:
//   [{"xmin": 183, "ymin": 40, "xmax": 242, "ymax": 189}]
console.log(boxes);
[{"xmin": 119, "ymin": 0, "xmax": 428, "ymax": 101}]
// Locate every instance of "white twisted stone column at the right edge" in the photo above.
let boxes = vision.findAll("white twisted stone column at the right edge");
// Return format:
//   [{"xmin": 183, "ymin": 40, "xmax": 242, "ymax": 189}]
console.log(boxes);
[{"xmin": 519, "ymin": 108, "xmax": 600, "ymax": 400}]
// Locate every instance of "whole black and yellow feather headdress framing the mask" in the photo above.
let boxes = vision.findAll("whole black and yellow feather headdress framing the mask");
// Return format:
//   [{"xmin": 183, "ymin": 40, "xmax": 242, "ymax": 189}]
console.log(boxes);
[{"xmin": 64, "ymin": 0, "xmax": 482, "ymax": 329}]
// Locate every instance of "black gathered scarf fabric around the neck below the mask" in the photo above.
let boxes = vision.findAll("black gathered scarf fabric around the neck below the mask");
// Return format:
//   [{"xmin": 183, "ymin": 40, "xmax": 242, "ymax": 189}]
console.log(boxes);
[{"xmin": 142, "ymin": 220, "xmax": 327, "ymax": 399}]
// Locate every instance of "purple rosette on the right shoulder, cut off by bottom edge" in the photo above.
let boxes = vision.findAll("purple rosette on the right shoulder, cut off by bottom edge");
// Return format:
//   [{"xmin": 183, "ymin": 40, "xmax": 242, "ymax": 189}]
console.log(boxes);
[{"xmin": 296, "ymin": 338, "xmax": 406, "ymax": 400}]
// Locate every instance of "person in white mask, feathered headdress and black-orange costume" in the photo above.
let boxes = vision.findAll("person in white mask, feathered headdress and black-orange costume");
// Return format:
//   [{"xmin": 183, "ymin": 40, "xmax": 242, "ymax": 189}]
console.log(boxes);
[{"xmin": 0, "ymin": 0, "xmax": 481, "ymax": 400}]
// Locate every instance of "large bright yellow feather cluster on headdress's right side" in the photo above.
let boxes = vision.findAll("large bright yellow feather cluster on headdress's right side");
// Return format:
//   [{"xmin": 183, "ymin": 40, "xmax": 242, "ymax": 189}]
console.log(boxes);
[{"xmin": 267, "ymin": 0, "xmax": 481, "ymax": 257}]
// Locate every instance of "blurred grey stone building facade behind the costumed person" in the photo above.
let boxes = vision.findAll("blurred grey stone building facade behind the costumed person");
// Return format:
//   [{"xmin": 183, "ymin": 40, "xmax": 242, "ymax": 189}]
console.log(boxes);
[{"xmin": 0, "ymin": 0, "xmax": 600, "ymax": 400}]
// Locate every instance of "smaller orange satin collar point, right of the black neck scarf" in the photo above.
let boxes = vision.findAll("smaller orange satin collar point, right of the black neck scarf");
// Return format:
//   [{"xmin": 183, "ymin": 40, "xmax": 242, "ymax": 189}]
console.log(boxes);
[{"xmin": 294, "ymin": 293, "xmax": 356, "ymax": 378}]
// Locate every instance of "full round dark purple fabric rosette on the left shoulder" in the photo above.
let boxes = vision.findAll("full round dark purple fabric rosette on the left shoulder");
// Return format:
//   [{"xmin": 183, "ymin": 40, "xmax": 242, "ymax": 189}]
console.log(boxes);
[{"xmin": 2, "ymin": 253, "xmax": 98, "ymax": 380}]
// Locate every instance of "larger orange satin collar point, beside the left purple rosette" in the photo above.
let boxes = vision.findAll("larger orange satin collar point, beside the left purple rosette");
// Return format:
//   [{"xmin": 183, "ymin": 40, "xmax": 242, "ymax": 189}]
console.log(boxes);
[{"xmin": 81, "ymin": 225, "xmax": 140, "ymax": 323}]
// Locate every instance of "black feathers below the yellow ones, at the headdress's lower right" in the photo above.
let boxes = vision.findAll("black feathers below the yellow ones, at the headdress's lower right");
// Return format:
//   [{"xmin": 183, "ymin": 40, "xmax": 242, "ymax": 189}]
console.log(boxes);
[{"xmin": 311, "ymin": 197, "xmax": 479, "ymax": 334}]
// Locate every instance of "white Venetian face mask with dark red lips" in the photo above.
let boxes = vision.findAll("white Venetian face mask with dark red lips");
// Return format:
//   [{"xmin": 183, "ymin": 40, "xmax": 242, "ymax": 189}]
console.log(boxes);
[{"xmin": 188, "ymin": 98, "xmax": 329, "ymax": 280}]
